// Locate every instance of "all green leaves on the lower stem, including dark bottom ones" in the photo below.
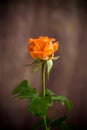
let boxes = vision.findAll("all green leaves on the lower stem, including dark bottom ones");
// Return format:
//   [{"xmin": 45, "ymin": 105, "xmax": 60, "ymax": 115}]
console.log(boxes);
[{"xmin": 12, "ymin": 80, "xmax": 73, "ymax": 130}]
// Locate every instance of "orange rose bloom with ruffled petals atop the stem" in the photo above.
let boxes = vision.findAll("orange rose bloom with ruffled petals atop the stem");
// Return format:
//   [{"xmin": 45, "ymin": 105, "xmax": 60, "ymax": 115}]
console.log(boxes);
[{"xmin": 28, "ymin": 36, "xmax": 59, "ymax": 60}]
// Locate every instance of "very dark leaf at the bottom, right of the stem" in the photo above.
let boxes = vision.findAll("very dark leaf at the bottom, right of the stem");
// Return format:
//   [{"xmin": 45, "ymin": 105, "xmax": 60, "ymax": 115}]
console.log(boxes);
[{"xmin": 51, "ymin": 116, "xmax": 67, "ymax": 128}]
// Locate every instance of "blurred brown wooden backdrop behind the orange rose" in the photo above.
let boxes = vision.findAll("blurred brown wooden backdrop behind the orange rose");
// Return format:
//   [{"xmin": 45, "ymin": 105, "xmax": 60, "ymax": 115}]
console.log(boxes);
[{"xmin": 0, "ymin": 0, "xmax": 87, "ymax": 130}]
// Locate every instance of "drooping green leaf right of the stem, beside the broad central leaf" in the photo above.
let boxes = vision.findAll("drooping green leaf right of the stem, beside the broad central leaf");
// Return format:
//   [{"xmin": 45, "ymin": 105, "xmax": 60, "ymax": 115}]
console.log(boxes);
[{"xmin": 51, "ymin": 95, "xmax": 73, "ymax": 110}]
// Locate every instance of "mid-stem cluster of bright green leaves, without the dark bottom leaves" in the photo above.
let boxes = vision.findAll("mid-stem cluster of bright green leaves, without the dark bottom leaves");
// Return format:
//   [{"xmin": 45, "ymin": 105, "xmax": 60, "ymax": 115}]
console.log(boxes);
[{"xmin": 12, "ymin": 80, "xmax": 73, "ymax": 117}]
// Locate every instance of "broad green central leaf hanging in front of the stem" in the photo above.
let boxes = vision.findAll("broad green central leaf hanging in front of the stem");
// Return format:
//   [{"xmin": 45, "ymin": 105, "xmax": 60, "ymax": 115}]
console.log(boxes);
[{"xmin": 29, "ymin": 96, "xmax": 52, "ymax": 117}]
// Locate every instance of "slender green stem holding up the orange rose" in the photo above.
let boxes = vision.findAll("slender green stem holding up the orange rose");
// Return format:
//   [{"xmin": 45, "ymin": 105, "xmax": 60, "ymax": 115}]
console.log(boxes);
[{"xmin": 42, "ymin": 62, "xmax": 48, "ymax": 130}]
